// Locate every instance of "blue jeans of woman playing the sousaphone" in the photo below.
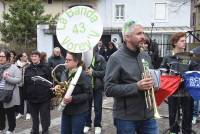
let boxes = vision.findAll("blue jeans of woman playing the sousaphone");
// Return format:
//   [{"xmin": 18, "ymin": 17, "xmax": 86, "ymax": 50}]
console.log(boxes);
[{"xmin": 61, "ymin": 112, "xmax": 87, "ymax": 134}]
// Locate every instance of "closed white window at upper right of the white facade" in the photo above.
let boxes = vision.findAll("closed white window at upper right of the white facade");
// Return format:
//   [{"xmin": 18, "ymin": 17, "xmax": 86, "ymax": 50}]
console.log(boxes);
[{"xmin": 154, "ymin": 3, "xmax": 167, "ymax": 21}]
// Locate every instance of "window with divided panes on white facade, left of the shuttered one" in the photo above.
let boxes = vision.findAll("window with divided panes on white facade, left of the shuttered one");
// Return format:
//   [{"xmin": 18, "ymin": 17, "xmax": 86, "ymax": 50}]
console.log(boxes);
[{"xmin": 115, "ymin": 4, "xmax": 125, "ymax": 20}]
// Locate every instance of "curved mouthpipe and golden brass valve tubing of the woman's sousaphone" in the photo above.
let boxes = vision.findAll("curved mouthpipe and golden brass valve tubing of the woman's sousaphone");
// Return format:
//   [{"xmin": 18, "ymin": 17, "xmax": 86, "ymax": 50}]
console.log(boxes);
[{"xmin": 51, "ymin": 64, "xmax": 68, "ymax": 106}]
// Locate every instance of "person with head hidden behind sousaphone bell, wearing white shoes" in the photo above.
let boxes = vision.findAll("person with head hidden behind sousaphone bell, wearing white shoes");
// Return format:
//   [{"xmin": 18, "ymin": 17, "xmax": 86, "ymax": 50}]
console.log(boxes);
[{"xmin": 84, "ymin": 50, "xmax": 106, "ymax": 134}]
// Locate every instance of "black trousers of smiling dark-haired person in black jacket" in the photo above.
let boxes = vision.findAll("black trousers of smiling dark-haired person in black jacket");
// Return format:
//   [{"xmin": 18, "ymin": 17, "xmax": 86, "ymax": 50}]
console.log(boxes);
[{"xmin": 29, "ymin": 101, "xmax": 50, "ymax": 134}]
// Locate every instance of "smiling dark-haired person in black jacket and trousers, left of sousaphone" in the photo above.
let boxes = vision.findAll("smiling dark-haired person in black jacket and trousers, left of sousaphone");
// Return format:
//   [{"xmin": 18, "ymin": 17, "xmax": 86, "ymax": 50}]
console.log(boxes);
[{"xmin": 24, "ymin": 51, "xmax": 51, "ymax": 134}]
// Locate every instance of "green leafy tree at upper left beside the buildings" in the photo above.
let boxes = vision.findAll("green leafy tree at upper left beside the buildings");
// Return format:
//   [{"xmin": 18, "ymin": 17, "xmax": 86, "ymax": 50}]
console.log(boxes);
[{"xmin": 0, "ymin": 0, "xmax": 51, "ymax": 50}]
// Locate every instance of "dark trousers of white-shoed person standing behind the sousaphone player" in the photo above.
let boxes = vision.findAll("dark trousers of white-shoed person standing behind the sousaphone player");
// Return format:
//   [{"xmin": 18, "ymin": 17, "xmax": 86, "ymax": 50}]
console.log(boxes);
[{"xmin": 86, "ymin": 89, "xmax": 103, "ymax": 127}]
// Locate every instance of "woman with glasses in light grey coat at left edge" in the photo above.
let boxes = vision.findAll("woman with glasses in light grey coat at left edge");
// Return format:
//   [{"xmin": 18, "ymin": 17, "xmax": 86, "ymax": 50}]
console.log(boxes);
[{"xmin": 0, "ymin": 50, "xmax": 22, "ymax": 134}]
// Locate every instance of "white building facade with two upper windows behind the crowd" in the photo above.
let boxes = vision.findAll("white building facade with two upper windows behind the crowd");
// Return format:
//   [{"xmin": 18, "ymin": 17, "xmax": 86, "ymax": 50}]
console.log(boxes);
[{"xmin": 0, "ymin": 0, "xmax": 191, "ymax": 57}]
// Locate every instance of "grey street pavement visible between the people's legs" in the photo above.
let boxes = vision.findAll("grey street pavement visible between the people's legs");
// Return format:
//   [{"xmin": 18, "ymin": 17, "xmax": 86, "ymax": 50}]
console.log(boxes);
[{"xmin": 15, "ymin": 97, "xmax": 200, "ymax": 134}]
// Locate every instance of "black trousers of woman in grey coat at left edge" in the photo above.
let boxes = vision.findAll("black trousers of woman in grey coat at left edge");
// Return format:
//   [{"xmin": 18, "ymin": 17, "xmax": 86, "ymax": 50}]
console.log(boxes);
[{"xmin": 0, "ymin": 102, "xmax": 16, "ymax": 132}]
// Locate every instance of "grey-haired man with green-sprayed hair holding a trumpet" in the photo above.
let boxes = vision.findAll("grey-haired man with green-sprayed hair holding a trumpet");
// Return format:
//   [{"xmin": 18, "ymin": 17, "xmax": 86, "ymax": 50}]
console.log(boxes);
[{"xmin": 105, "ymin": 21, "xmax": 159, "ymax": 134}]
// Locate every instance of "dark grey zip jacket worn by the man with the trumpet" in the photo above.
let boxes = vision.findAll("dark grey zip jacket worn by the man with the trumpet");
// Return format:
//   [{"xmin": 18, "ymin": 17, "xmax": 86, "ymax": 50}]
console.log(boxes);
[{"xmin": 104, "ymin": 45, "xmax": 153, "ymax": 120}]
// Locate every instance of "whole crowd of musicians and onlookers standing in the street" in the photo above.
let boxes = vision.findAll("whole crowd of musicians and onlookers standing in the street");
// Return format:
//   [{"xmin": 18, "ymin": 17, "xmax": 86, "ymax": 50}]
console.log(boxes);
[{"xmin": 0, "ymin": 21, "xmax": 199, "ymax": 134}]
